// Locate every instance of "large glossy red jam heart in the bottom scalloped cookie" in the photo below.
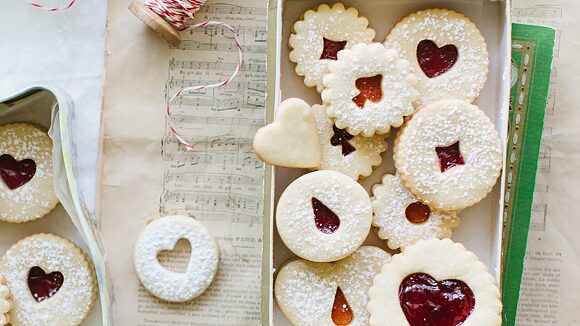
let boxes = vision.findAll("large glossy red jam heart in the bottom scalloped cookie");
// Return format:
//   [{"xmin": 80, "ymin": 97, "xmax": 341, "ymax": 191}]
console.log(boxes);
[{"xmin": 399, "ymin": 273, "xmax": 475, "ymax": 326}]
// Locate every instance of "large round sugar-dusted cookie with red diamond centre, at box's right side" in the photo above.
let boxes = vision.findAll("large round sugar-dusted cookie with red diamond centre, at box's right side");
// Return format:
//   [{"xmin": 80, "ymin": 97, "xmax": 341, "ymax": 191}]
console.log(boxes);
[{"xmin": 393, "ymin": 100, "xmax": 503, "ymax": 211}]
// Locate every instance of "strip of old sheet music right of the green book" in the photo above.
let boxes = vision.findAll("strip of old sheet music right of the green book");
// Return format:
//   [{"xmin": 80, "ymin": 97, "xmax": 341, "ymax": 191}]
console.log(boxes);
[{"xmin": 512, "ymin": 0, "xmax": 580, "ymax": 326}]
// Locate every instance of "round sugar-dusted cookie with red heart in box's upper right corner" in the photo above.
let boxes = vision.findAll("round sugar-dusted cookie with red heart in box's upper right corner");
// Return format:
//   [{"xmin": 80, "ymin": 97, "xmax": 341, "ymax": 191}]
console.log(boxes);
[{"xmin": 385, "ymin": 9, "xmax": 489, "ymax": 106}]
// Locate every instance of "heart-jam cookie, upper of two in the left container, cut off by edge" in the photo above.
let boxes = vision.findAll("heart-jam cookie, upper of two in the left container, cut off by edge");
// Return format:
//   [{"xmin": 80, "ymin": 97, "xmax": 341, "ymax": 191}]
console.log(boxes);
[{"xmin": 0, "ymin": 123, "xmax": 58, "ymax": 223}]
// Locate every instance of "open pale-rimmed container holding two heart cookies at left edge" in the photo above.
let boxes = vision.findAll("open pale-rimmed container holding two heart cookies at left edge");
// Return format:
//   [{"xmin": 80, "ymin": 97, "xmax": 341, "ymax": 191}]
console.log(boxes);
[{"xmin": 0, "ymin": 87, "xmax": 111, "ymax": 326}]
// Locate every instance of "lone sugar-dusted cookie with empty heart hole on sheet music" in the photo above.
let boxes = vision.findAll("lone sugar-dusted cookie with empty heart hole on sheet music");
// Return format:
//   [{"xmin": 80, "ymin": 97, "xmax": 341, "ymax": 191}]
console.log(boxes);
[{"xmin": 134, "ymin": 215, "xmax": 219, "ymax": 302}]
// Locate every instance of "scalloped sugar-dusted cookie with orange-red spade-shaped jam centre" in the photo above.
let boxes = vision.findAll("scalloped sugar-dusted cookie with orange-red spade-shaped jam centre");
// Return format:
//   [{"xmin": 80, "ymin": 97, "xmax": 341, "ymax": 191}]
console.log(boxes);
[{"xmin": 322, "ymin": 43, "xmax": 419, "ymax": 137}]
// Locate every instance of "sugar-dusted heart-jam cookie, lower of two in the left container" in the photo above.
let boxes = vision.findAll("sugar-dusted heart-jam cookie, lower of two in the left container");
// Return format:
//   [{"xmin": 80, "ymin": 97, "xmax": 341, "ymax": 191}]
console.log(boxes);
[{"xmin": 0, "ymin": 234, "xmax": 97, "ymax": 326}]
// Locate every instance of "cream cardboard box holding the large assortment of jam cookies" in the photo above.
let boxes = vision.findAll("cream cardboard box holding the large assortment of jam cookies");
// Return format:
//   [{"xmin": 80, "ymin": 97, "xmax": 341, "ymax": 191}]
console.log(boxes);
[{"xmin": 263, "ymin": 0, "xmax": 511, "ymax": 325}]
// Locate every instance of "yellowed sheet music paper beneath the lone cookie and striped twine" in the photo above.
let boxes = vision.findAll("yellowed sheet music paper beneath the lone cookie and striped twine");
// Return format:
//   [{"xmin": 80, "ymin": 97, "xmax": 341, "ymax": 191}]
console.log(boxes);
[{"xmin": 99, "ymin": 0, "xmax": 267, "ymax": 326}]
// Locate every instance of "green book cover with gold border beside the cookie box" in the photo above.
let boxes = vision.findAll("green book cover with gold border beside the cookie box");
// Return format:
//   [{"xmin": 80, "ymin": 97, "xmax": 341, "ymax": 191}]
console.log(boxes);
[{"xmin": 502, "ymin": 24, "xmax": 555, "ymax": 326}]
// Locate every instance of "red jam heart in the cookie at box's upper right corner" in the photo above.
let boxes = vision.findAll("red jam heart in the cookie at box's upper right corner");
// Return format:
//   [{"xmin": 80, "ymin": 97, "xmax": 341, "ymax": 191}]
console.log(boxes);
[{"xmin": 417, "ymin": 40, "xmax": 459, "ymax": 78}]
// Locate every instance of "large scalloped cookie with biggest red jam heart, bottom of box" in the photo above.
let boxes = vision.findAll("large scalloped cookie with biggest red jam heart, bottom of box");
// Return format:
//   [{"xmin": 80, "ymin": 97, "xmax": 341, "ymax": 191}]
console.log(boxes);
[{"xmin": 367, "ymin": 239, "xmax": 502, "ymax": 326}]
